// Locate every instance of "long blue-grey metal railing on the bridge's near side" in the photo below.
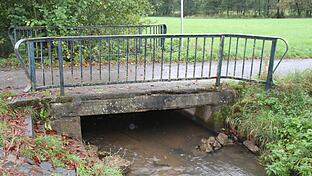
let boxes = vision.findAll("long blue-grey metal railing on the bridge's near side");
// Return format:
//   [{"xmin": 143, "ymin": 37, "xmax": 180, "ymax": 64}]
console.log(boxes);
[{"xmin": 15, "ymin": 34, "xmax": 288, "ymax": 95}]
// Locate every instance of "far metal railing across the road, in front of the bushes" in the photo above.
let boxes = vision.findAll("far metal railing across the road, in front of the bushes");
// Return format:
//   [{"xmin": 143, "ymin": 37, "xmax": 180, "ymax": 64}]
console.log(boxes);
[{"xmin": 8, "ymin": 24, "xmax": 167, "ymax": 46}]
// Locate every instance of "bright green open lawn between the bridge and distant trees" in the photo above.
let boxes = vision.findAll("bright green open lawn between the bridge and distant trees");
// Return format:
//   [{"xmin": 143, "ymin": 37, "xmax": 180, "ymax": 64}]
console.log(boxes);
[{"xmin": 148, "ymin": 17, "xmax": 312, "ymax": 58}]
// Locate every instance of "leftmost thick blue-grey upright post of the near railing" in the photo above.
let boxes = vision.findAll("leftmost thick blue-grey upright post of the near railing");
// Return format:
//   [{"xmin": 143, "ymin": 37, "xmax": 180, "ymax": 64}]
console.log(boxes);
[{"xmin": 27, "ymin": 41, "xmax": 36, "ymax": 91}]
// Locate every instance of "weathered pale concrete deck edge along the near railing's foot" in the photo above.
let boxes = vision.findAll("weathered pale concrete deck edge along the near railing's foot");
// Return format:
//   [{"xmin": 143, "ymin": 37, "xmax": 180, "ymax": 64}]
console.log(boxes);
[{"xmin": 8, "ymin": 80, "xmax": 214, "ymax": 102}]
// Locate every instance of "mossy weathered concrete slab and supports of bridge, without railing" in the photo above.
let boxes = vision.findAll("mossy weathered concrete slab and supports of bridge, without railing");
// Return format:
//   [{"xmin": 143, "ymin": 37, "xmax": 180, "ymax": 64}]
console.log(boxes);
[{"xmin": 44, "ymin": 81, "xmax": 235, "ymax": 139}]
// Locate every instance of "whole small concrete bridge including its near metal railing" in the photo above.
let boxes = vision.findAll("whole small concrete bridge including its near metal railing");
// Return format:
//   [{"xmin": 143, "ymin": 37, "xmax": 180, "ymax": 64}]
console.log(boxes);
[{"xmin": 11, "ymin": 25, "xmax": 288, "ymax": 138}]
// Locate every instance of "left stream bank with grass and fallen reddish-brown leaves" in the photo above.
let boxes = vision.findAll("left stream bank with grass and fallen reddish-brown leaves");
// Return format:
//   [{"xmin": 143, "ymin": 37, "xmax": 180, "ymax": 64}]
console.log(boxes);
[{"xmin": 0, "ymin": 92, "xmax": 122, "ymax": 176}]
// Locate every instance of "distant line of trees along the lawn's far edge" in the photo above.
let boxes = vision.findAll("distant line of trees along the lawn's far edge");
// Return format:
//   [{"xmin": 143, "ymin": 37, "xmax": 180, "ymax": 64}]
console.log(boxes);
[{"xmin": 150, "ymin": 0, "xmax": 312, "ymax": 18}]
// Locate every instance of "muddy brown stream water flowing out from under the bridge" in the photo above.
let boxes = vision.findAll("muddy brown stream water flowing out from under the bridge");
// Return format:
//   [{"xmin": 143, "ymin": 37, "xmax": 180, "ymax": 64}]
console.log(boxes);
[{"xmin": 82, "ymin": 111, "xmax": 265, "ymax": 176}]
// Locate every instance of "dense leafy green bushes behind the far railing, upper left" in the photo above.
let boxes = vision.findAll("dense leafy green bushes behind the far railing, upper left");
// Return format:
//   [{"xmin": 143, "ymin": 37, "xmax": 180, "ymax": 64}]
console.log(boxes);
[{"xmin": 0, "ymin": 0, "xmax": 150, "ymax": 56}]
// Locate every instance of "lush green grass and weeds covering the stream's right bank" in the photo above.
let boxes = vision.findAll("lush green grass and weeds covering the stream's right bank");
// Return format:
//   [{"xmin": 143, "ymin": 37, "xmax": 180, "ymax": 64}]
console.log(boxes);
[{"xmin": 221, "ymin": 69, "xmax": 312, "ymax": 176}]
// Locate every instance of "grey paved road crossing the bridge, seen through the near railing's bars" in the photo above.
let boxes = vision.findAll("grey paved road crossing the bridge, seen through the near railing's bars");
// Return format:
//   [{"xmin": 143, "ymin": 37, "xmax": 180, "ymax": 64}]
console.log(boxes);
[{"xmin": 0, "ymin": 59, "xmax": 312, "ymax": 91}]
